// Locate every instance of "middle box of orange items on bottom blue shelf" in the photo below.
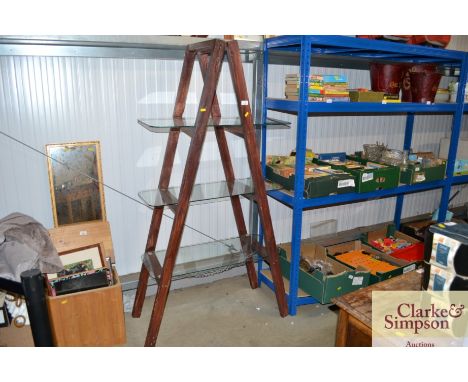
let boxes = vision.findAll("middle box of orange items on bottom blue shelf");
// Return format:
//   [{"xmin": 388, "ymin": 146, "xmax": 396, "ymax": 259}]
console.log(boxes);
[{"xmin": 326, "ymin": 240, "xmax": 416, "ymax": 285}]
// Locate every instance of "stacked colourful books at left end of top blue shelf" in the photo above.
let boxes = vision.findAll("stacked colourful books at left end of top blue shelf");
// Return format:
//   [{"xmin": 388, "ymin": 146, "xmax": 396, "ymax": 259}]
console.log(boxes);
[{"xmin": 285, "ymin": 74, "xmax": 349, "ymax": 102}]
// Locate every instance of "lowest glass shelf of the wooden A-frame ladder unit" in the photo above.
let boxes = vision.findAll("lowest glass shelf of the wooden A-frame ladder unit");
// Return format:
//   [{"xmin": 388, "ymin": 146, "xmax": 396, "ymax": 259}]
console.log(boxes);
[{"xmin": 142, "ymin": 235, "xmax": 258, "ymax": 280}]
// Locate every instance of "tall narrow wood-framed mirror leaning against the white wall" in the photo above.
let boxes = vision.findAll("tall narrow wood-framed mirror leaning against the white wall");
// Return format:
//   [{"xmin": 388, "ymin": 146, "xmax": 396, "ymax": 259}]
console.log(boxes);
[{"xmin": 46, "ymin": 141, "xmax": 106, "ymax": 227}]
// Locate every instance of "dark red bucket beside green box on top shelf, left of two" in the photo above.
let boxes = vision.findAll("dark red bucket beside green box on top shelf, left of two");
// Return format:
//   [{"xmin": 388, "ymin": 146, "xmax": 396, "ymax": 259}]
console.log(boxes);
[{"xmin": 370, "ymin": 62, "xmax": 405, "ymax": 94}]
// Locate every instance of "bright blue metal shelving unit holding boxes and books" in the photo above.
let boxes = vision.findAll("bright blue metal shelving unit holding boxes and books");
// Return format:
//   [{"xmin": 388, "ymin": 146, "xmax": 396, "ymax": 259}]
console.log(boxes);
[{"xmin": 259, "ymin": 36, "xmax": 468, "ymax": 315}]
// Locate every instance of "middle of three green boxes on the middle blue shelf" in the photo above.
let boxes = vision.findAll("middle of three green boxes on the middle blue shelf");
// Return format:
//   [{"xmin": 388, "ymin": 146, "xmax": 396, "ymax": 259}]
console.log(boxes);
[{"xmin": 314, "ymin": 154, "xmax": 400, "ymax": 193}]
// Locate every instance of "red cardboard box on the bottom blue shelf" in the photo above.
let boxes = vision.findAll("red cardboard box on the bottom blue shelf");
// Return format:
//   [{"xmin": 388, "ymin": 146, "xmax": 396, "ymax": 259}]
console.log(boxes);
[{"xmin": 361, "ymin": 225, "xmax": 424, "ymax": 261}]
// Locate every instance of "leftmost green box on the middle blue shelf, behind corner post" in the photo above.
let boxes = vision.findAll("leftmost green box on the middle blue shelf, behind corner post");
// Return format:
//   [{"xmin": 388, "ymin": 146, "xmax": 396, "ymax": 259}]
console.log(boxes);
[{"xmin": 265, "ymin": 165, "xmax": 355, "ymax": 198}]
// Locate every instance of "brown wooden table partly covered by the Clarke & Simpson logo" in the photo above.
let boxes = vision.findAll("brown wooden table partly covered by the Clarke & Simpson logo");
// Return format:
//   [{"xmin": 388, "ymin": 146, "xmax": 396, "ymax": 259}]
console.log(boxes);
[{"xmin": 332, "ymin": 271, "xmax": 422, "ymax": 346}]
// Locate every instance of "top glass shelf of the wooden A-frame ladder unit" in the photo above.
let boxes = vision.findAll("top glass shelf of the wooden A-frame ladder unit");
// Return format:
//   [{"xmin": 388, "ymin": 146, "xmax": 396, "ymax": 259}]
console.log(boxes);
[{"xmin": 138, "ymin": 117, "xmax": 291, "ymax": 133}]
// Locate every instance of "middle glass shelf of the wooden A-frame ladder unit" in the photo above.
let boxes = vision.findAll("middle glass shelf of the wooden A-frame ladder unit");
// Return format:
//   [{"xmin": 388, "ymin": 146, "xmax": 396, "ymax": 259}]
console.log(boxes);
[{"xmin": 138, "ymin": 178, "xmax": 281, "ymax": 207}]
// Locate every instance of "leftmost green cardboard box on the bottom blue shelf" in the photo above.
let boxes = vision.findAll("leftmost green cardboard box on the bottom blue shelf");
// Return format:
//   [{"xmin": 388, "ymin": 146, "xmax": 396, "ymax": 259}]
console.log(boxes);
[{"xmin": 279, "ymin": 242, "xmax": 370, "ymax": 304}]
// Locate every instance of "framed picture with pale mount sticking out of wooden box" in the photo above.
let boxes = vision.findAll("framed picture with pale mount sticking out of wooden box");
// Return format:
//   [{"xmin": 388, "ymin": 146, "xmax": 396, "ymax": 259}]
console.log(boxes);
[{"xmin": 47, "ymin": 243, "xmax": 105, "ymax": 281}]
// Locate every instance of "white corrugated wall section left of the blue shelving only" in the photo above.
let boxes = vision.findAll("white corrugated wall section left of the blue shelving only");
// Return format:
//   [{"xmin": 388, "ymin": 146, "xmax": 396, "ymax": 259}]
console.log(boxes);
[{"xmin": 0, "ymin": 56, "xmax": 252, "ymax": 274}]
